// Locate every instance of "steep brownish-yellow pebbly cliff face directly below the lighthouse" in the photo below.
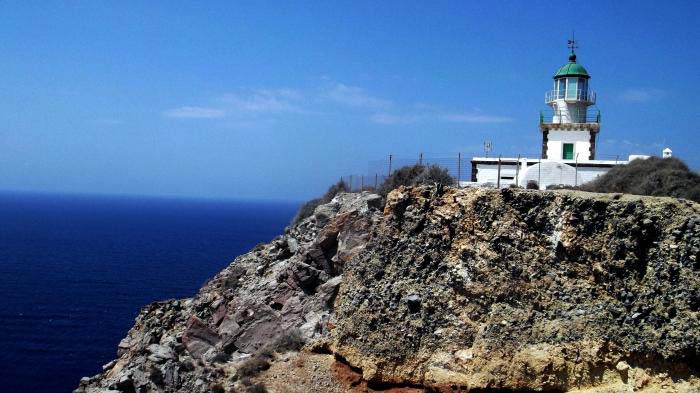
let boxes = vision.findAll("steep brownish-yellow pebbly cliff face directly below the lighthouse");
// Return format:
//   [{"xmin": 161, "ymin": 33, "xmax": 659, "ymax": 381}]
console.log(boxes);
[{"xmin": 332, "ymin": 188, "xmax": 700, "ymax": 390}]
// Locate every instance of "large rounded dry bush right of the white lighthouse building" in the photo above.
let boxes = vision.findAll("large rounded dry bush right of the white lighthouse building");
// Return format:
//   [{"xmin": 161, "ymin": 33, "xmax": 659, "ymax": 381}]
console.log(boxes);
[{"xmin": 579, "ymin": 157, "xmax": 700, "ymax": 202}]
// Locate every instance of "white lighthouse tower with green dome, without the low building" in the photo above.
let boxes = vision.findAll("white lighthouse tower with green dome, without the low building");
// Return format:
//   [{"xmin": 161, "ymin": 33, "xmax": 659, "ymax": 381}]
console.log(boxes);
[{"xmin": 540, "ymin": 39, "xmax": 600, "ymax": 162}]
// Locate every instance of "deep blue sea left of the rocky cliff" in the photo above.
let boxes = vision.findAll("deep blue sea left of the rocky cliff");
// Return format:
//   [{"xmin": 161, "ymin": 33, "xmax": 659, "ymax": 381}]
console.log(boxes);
[{"xmin": 0, "ymin": 193, "xmax": 298, "ymax": 393}]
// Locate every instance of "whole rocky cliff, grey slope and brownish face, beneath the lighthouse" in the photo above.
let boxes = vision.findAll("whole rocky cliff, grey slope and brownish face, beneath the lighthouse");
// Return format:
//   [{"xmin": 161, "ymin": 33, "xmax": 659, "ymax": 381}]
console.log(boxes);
[{"xmin": 76, "ymin": 187, "xmax": 700, "ymax": 393}]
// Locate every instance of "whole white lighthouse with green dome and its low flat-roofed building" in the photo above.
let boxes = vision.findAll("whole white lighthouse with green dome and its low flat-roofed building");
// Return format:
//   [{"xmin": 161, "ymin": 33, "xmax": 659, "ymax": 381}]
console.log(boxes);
[{"xmin": 471, "ymin": 44, "xmax": 640, "ymax": 189}]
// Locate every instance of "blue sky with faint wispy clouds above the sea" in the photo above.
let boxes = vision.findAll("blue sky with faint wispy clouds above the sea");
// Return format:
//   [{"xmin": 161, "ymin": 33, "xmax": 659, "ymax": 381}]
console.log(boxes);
[{"xmin": 0, "ymin": 0, "xmax": 700, "ymax": 199}]
